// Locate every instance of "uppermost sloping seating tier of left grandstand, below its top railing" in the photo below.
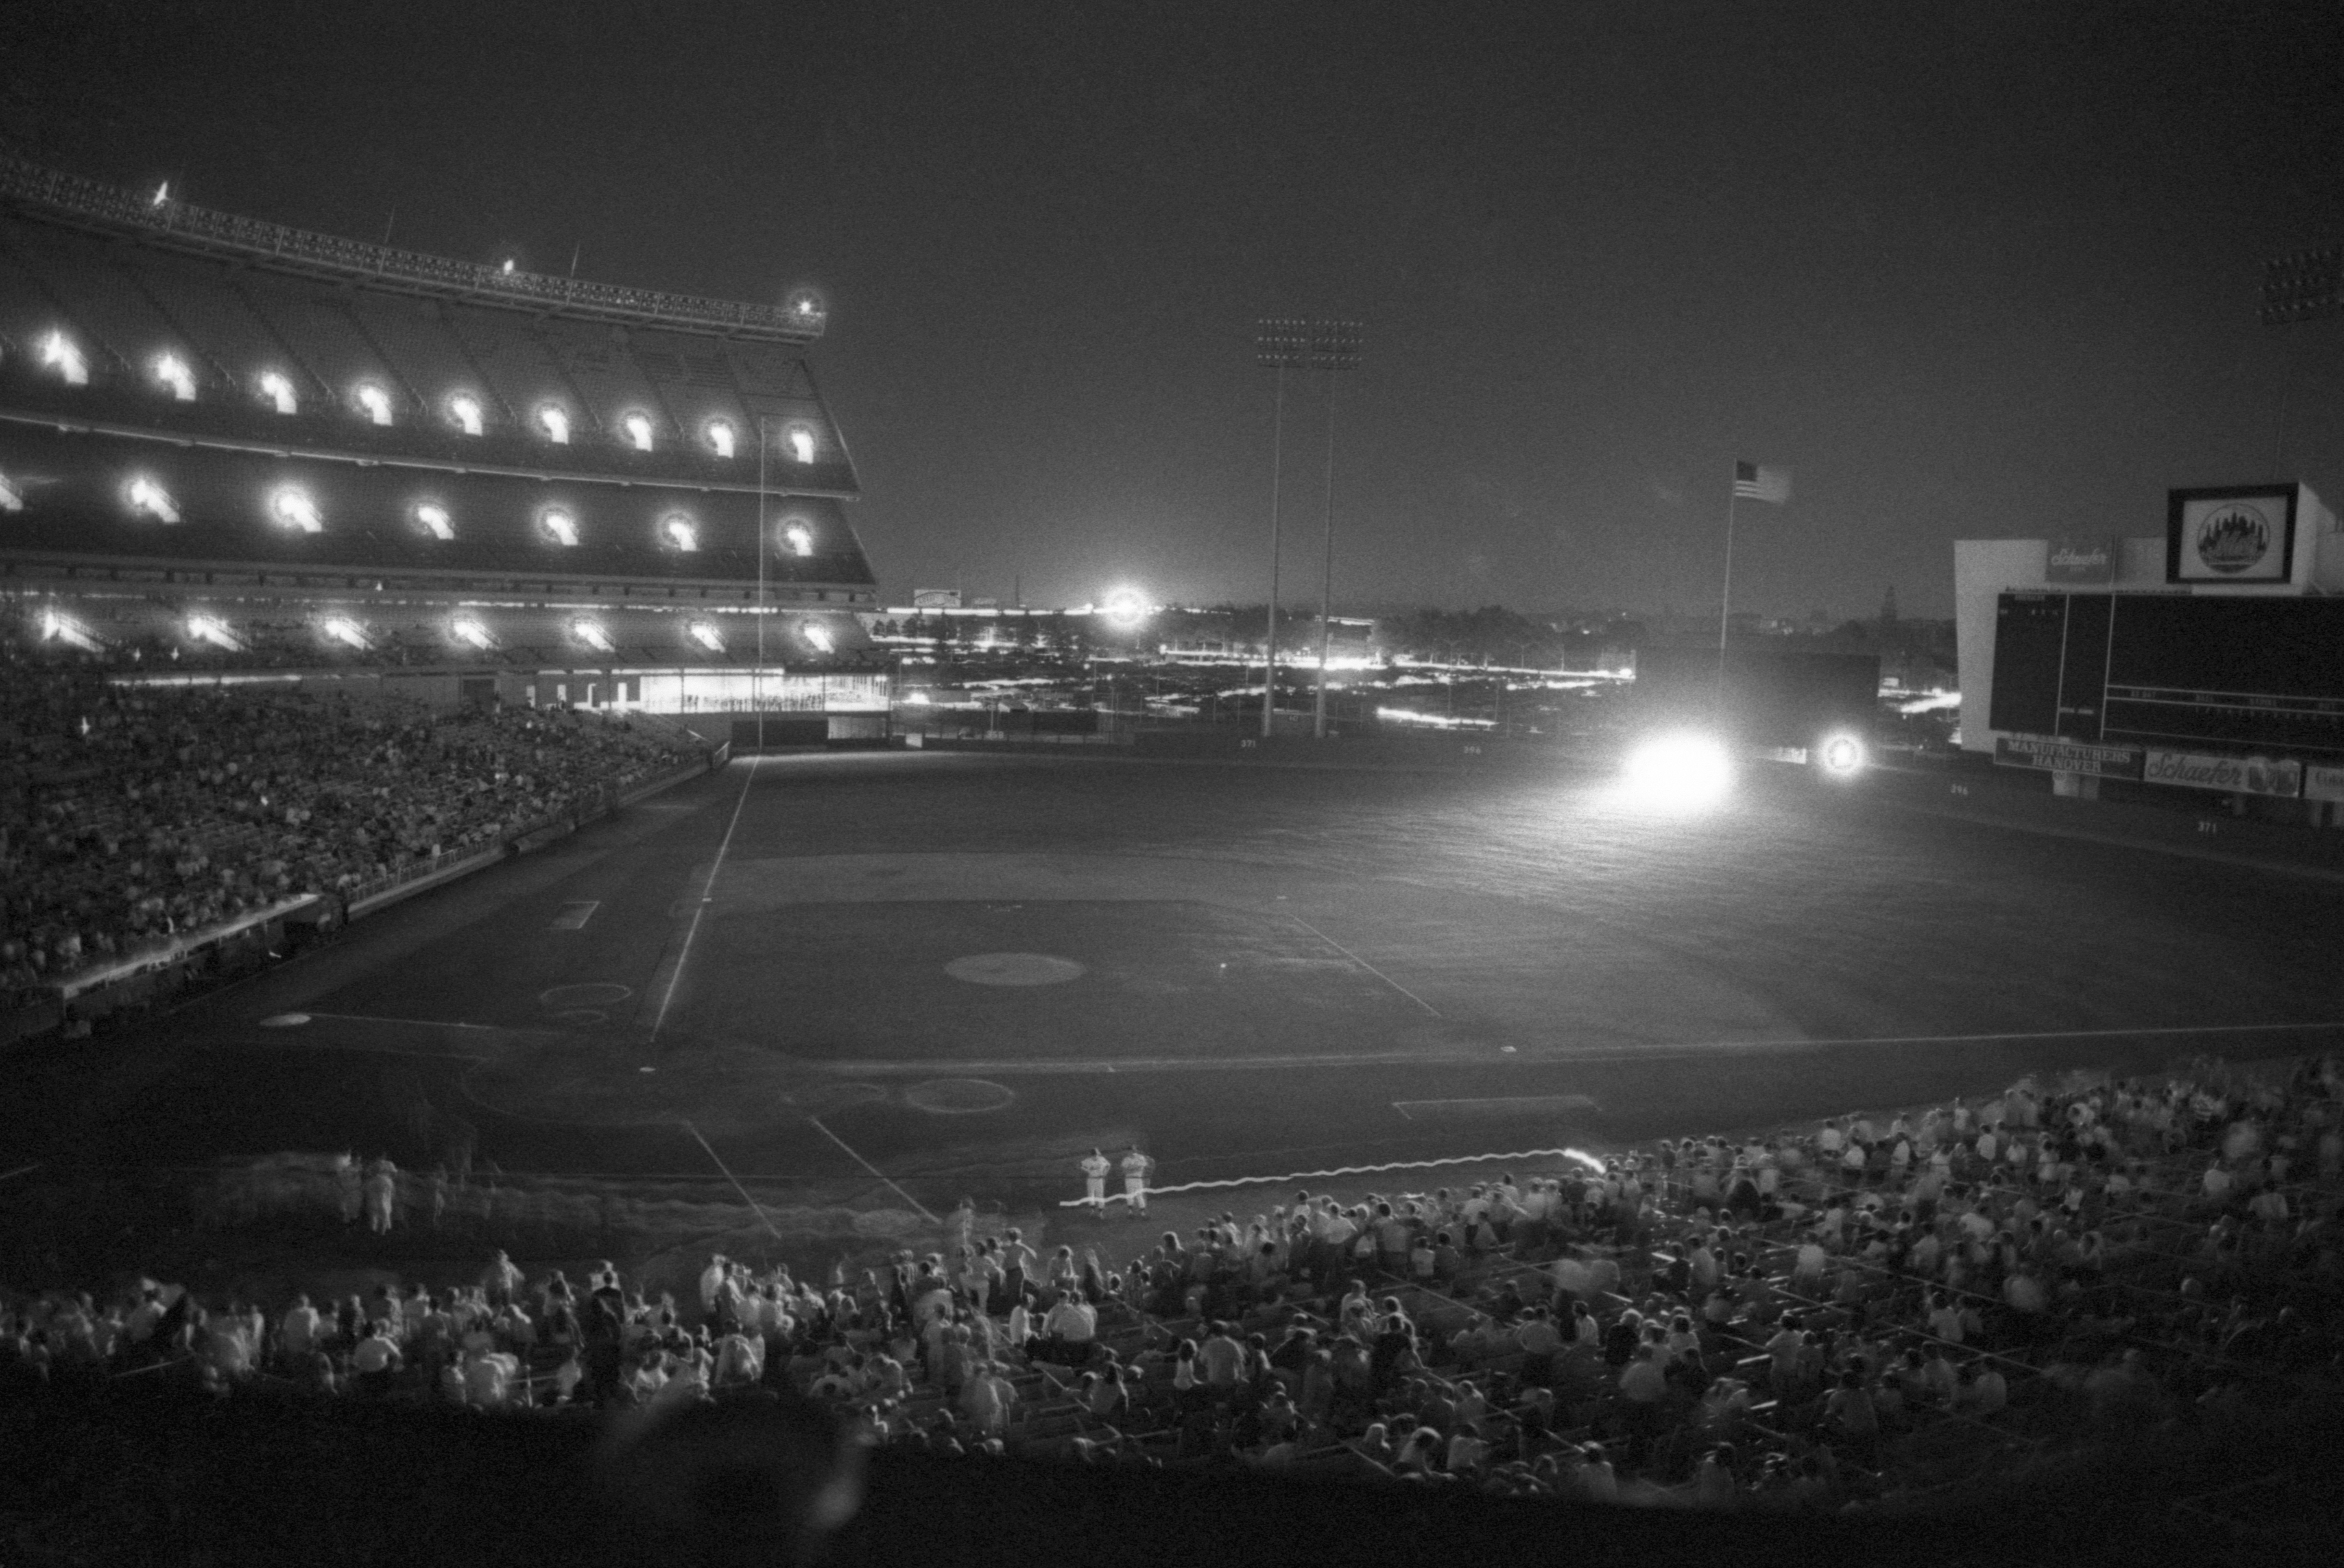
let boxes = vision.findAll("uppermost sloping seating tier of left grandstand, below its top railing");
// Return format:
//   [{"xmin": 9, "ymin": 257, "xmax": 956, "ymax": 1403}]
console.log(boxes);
[{"xmin": 0, "ymin": 174, "xmax": 853, "ymax": 495}]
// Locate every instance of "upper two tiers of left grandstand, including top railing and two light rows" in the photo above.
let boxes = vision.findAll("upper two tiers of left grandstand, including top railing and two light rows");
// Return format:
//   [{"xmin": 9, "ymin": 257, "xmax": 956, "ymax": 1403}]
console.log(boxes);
[{"xmin": 0, "ymin": 159, "xmax": 874, "ymax": 607}]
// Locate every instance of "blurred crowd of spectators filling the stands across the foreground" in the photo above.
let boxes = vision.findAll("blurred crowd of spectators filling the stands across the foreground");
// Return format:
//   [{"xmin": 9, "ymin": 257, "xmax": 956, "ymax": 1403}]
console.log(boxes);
[{"xmin": 0, "ymin": 1060, "xmax": 2344, "ymax": 1509}]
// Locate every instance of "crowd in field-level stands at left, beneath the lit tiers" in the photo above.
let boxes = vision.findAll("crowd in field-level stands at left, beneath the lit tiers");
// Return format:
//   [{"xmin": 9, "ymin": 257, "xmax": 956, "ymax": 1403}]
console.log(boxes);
[{"xmin": 0, "ymin": 666, "xmax": 689, "ymax": 999}]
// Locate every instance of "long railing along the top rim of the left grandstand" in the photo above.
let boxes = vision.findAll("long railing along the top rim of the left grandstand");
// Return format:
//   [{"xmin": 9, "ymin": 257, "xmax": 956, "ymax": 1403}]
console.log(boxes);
[{"xmin": 0, "ymin": 153, "xmax": 825, "ymax": 345}]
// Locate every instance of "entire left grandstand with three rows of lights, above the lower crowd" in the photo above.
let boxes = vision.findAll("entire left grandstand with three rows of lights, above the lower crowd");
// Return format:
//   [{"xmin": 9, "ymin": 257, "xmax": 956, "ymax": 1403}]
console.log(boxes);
[{"xmin": 0, "ymin": 157, "xmax": 884, "ymax": 736}]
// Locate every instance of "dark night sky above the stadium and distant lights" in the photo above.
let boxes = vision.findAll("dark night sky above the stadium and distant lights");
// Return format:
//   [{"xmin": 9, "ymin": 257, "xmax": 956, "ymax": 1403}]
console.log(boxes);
[{"xmin": 0, "ymin": 0, "xmax": 2344, "ymax": 616}]
